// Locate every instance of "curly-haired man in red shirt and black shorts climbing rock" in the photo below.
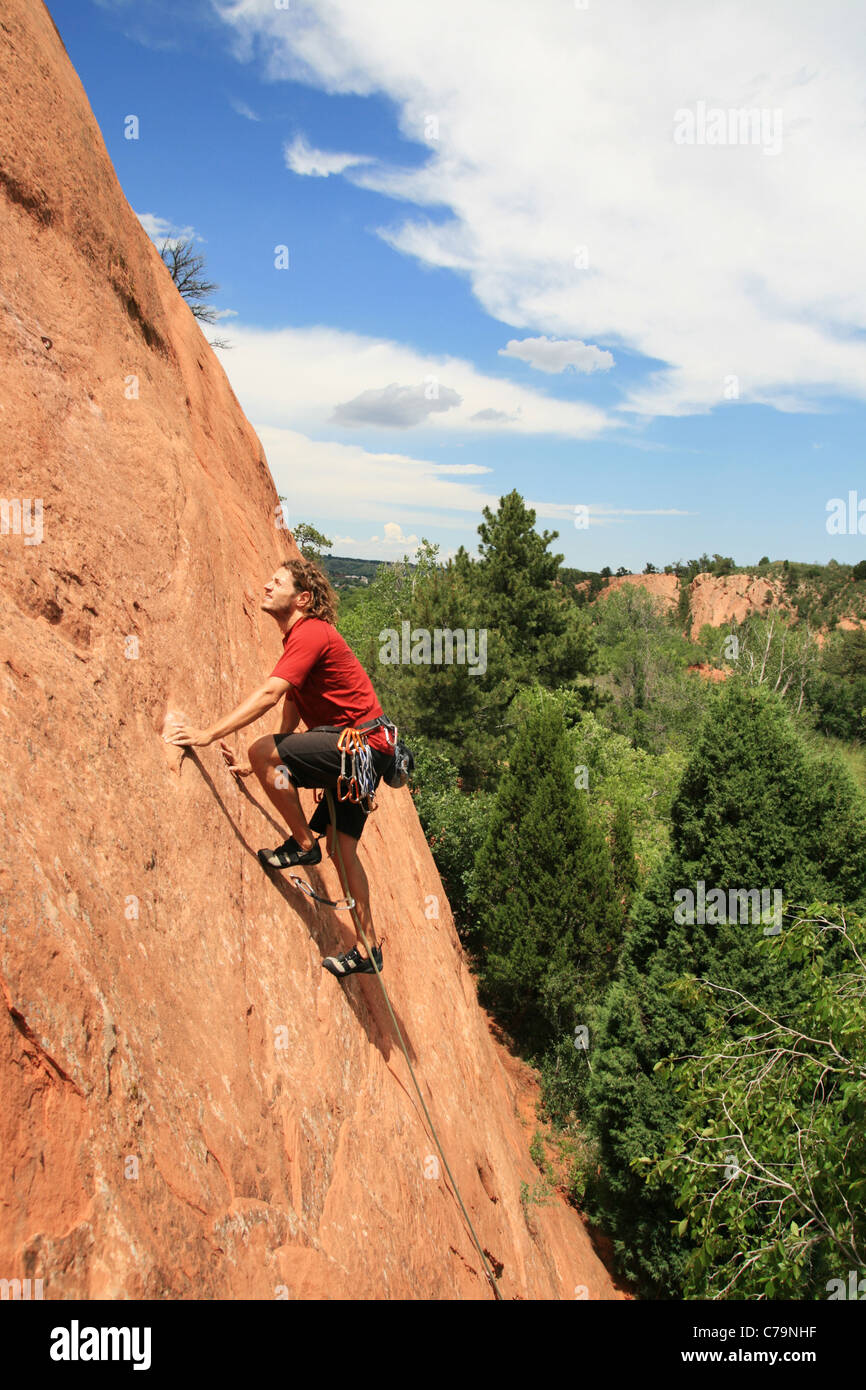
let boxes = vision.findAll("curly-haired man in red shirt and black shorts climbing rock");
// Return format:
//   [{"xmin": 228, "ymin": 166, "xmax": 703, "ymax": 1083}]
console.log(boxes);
[{"xmin": 164, "ymin": 560, "xmax": 396, "ymax": 979}]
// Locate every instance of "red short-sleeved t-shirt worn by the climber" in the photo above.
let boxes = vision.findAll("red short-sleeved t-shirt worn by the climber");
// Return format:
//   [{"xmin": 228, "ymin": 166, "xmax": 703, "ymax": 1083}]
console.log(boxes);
[{"xmin": 271, "ymin": 617, "xmax": 391, "ymax": 753}]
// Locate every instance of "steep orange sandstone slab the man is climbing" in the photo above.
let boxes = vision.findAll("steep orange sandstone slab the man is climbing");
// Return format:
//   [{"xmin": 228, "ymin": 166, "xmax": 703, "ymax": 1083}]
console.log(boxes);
[{"xmin": 0, "ymin": 0, "xmax": 621, "ymax": 1298}]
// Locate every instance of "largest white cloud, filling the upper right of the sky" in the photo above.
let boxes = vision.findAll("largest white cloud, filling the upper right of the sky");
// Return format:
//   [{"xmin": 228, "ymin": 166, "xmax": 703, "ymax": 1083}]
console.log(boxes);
[{"xmin": 215, "ymin": 0, "xmax": 866, "ymax": 428}]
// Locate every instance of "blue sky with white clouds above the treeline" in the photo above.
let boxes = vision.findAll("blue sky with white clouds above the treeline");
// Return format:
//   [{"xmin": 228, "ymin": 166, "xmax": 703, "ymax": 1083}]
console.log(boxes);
[{"xmin": 49, "ymin": 0, "xmax": 866, "ymax": 570}]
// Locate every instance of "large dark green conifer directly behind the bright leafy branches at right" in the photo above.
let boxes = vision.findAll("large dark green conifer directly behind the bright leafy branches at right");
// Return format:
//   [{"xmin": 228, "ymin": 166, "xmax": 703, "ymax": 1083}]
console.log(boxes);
[{"xmin": 588, "ymin": 682, "xmax": 866, "ymax": 1297}]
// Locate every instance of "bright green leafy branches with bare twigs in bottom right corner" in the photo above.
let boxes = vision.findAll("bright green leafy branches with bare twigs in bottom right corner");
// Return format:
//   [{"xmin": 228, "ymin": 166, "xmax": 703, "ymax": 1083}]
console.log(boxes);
[{"xmin": 649, "ymin": 904, "xmax": 866, "ymax": 1298}]
